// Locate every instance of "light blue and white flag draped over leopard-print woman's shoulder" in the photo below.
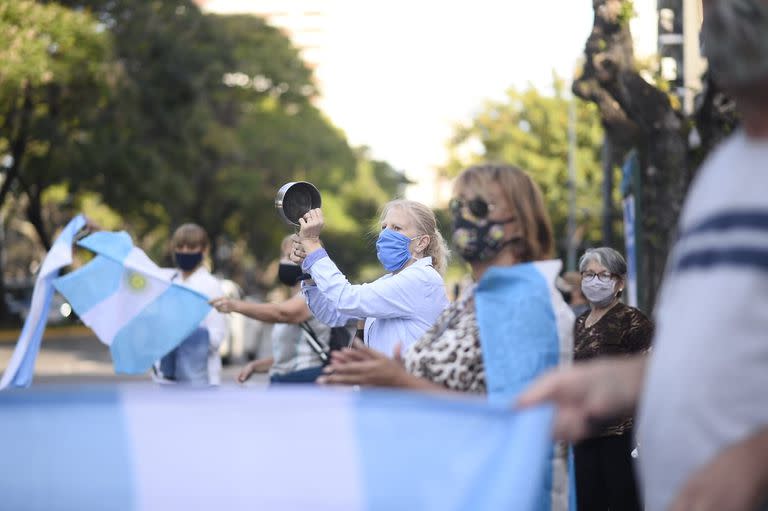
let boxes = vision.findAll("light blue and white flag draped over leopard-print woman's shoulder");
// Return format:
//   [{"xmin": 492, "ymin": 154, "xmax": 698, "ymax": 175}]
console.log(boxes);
[{"xmin": 475, "ymin": 261, "xmax": 576, "ymax": 511}]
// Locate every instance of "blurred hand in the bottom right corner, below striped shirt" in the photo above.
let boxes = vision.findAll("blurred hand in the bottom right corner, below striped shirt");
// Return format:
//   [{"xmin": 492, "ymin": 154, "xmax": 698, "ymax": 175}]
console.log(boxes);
[{"xmin": 670, "ymin": 439, "xmax": 768, "ymax": 511}]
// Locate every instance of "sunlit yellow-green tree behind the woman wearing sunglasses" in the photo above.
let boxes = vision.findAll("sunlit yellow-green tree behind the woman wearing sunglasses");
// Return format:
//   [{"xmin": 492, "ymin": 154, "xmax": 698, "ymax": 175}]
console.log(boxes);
[{"xmin": 443, "ymin": 77, "xmax": 608, "ymax": 264}]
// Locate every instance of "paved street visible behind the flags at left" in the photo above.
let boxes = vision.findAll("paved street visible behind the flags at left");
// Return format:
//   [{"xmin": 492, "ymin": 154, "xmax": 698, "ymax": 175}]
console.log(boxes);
[{"xmin": 0, "ymin": 328, "xmax": 267, "ymax": 386}]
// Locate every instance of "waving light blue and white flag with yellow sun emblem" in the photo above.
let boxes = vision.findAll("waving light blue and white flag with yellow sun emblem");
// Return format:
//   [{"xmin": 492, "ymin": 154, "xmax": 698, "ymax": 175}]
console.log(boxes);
[{"xmin": 54, "ymin": 232, "xmax": 211, "ymax": 374}]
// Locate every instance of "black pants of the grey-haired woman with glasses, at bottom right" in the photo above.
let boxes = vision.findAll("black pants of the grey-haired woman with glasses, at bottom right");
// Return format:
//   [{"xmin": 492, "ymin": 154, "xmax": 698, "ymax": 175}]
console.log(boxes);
[{"xmin": 573, "ymin": 431, "xmax": 641, "ymax": 511}]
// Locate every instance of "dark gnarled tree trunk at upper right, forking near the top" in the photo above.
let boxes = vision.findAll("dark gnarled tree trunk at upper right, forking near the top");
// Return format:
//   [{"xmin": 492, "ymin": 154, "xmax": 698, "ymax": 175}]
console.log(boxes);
[{"xmin": 573, "ymin": 0, "xmax": 736, "ymax": 310}]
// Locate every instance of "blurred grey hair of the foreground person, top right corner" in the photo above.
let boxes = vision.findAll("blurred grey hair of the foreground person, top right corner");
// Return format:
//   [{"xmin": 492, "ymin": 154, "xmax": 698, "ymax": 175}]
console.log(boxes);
[{"xmin": 701, "ymin": 0, "xmax": 768, "ymax": 85}]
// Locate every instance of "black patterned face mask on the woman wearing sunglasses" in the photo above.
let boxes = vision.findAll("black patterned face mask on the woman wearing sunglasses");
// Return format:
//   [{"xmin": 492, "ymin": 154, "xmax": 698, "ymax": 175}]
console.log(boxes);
[{"xmin": 452, "ymin": 213, "xmax": 517, "ymax": 262}]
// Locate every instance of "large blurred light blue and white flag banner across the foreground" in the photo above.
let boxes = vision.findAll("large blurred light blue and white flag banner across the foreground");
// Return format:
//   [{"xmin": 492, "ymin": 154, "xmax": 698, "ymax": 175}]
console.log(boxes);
[{"xmin": 0, "ymin": 385, "xmax": 553, "ymax": 511}]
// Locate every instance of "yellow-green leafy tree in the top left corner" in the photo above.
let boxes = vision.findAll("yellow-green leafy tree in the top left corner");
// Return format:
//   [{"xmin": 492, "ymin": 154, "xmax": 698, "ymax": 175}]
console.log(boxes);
[{"xmin": 0, "ymin": 0, "xmax": 110, "ymax": 316}]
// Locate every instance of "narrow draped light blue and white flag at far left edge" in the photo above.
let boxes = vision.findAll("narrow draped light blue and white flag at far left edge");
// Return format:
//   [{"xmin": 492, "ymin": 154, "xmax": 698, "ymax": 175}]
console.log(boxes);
[{"xmin": 0, "ymin": 215, "xmax": 86, "ymax": 389}]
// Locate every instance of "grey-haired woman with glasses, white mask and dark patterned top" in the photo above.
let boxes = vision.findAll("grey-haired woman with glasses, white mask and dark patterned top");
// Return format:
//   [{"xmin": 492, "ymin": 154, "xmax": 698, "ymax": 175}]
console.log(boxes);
[{"xmin": 574, "ymin": 247, "xmax": 653, "ymax": 510}]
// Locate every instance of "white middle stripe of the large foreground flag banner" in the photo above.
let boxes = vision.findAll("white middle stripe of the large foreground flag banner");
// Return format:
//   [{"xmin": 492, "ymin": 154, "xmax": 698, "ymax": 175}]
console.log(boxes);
[{"xmin": 121, "ymin": 389, "xmax": 366, "ymax": 511}]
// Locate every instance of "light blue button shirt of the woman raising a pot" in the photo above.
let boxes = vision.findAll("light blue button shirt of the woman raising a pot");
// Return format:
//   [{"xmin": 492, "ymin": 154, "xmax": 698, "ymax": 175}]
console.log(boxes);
[{"xmin": 302, "ymin": 254, "xmax": 448, "ymax": 356}]
